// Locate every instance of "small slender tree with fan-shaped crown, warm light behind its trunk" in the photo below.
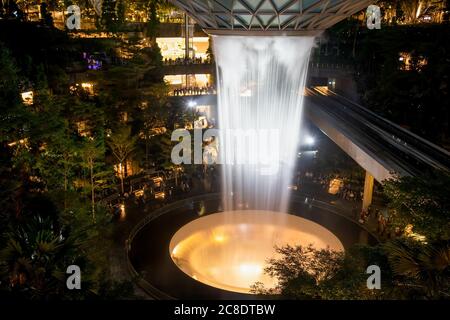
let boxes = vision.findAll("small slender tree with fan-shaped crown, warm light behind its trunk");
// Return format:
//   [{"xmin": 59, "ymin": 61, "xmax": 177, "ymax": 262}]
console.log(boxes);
[{"xmin": 108, "ymin": 126, "xmax": 137, "ymax": 194}]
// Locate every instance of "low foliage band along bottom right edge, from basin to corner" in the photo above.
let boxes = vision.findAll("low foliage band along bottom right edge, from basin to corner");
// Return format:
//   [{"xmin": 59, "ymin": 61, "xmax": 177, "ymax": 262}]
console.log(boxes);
[{"xmin": 252, "ymin": 238, "xmax": 450, "ymax": 300}]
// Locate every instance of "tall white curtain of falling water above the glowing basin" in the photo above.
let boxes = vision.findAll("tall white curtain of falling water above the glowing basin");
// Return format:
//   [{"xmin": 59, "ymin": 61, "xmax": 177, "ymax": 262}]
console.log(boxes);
[{"xmin": 214, "ymin": 36, "xmax": 314, "ymax": 212}]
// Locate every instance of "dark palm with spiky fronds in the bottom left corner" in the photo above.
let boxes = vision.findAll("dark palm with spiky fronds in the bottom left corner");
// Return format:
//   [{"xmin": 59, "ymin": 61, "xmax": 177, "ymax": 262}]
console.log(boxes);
[{"xmin": 0, "ymin": 216, "xmax": 84, "ymax": 299}]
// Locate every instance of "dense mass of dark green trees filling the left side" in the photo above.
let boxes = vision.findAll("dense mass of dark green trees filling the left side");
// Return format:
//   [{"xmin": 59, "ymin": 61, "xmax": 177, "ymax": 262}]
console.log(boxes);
[{"xmin": 0, "ymin": 15, "xmax": 172, "ymax": 299}]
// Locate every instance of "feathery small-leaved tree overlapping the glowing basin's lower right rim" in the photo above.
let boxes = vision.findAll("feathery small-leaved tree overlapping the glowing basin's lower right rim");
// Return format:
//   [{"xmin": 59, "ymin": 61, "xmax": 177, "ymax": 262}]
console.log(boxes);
[{"xmin": 252, "ymin": 245, "xmax": 392, "ymax": 300}]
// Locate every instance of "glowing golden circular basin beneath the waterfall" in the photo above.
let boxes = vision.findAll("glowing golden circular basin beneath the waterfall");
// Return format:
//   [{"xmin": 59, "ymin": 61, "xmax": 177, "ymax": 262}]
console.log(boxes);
[{"xmin": 169, "ymin": 210, "xmax": 344, "ymax": 293}]
